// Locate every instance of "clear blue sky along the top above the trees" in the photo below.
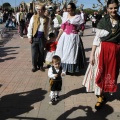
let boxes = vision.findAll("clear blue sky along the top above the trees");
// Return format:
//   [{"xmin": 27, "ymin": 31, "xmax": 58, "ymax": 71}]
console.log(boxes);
[{"xmin": 0, "ymin": 0, "xmax": 104, "ymax": 8}]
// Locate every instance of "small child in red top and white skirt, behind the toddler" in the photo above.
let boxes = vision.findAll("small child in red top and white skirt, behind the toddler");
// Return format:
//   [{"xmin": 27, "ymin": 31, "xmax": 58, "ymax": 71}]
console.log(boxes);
[{"xmin": 45, "ymin": 33, "xmax": 57, "ymax": 68}]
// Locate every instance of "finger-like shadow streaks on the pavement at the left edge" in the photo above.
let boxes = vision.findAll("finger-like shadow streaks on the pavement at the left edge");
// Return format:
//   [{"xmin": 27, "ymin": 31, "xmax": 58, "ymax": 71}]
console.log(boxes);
[{"xmin": 0, "ymin": 47, "xmax": 19, "ymax": 62}]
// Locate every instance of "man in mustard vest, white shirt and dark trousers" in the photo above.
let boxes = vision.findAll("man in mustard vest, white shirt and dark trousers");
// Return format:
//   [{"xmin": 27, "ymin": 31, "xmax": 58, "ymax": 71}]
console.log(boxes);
[{"xmin": 27, "ymin": 3, "xmax": 49, "ymax": 72}]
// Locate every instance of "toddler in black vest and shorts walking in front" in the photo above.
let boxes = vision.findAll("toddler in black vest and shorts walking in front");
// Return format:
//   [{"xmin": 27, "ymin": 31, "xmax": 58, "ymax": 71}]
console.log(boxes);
[{"xmin": 48, "ymin": 55, "xmax": 65, "ymax": 104}]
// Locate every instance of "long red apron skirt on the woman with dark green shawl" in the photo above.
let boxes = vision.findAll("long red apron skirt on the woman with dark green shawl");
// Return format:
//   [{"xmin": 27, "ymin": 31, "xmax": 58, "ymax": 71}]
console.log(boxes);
[{"xmin": 96, "ymin": 42, "xmax": 120, "ymax": 92}]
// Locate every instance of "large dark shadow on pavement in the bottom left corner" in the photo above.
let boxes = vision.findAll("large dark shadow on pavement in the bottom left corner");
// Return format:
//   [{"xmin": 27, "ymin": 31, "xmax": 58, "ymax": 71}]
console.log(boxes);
[{"xmin": 0, "ymin": 89, "xmax": 47, "ymax": 120}]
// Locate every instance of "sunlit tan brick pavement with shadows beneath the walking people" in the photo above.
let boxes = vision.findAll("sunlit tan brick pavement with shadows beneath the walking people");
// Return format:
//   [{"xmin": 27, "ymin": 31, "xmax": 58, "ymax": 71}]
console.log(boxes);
[{"xmin": 0, "ymin": 22, "xmax": 120, "ymax": 120}]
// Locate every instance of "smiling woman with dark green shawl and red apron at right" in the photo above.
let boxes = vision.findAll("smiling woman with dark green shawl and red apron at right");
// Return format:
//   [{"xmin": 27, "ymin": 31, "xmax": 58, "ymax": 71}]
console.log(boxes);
[{"xmin": 83, "ymin": 0, "xmax": 120, "ymax": 110}]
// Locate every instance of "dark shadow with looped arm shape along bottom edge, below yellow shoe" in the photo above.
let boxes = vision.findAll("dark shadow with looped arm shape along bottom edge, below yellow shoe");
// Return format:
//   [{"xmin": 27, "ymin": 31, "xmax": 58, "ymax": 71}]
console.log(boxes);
[{"xmin": 56, "ymin": 105, "xmax": 114, "ymax": 120}]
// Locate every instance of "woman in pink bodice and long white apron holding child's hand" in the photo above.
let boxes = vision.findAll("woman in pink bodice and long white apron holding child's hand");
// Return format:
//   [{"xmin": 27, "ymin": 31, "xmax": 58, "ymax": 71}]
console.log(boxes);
[{"xmin": 55, "ymin": 3, "xmax": 85, "ymax": 73}]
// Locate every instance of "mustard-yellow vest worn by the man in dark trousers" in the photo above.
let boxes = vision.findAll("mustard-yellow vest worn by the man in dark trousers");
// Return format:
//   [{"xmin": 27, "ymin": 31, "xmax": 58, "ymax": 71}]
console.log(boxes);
[{"xmin": 32, "ymin": 15, "xmax": 49, "ymax": 37}]
